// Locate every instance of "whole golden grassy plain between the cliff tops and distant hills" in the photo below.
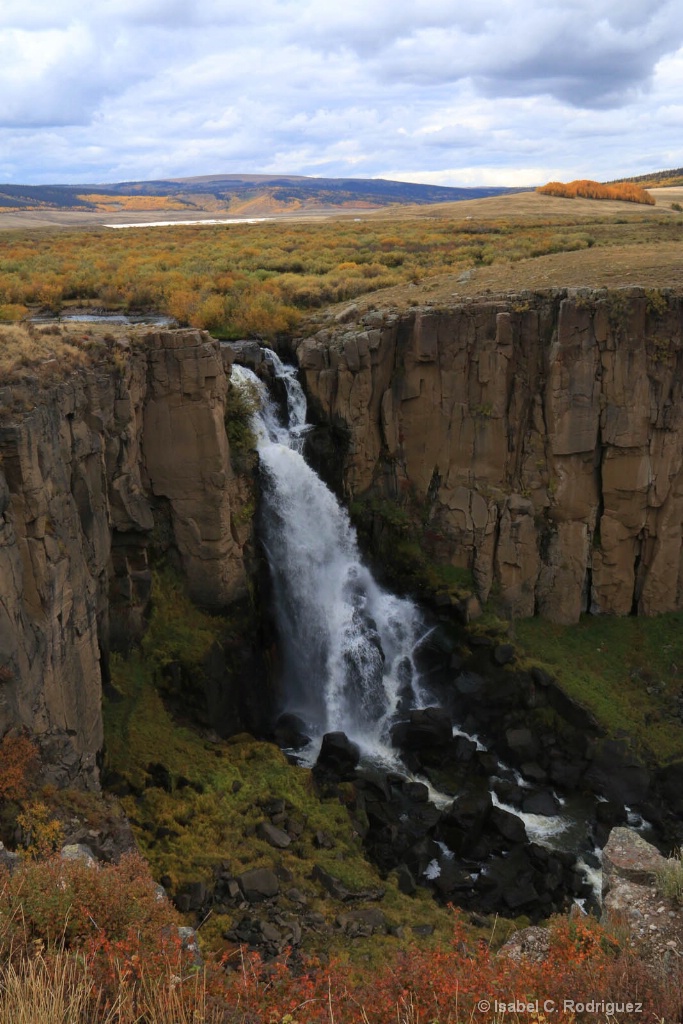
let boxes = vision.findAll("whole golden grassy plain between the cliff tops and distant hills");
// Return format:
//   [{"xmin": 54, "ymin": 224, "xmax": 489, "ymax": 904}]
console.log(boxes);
[{"xmin": 0, "ymin": 189, "xmax": 683, "ymax": 339}]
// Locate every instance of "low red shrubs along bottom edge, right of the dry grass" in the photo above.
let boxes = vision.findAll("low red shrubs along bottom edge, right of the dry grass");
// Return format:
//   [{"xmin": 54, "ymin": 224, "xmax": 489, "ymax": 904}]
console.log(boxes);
[{"xmin": 201, "ymin": 914, "xmax": 683, "ymax": 1024}]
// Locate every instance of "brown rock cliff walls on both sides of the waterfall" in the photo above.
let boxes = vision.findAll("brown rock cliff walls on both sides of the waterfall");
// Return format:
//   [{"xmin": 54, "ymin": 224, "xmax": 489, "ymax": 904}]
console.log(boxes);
[{"xmin": 0, "ymin": 289, "xmax": 683, "ymax": 786}]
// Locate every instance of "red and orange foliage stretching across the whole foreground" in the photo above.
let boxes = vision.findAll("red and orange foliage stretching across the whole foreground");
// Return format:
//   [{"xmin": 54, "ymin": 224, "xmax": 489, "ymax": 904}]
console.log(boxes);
[{"xmin": 0, "ymin": 856, "xmax": 683, "ymax": 1024}]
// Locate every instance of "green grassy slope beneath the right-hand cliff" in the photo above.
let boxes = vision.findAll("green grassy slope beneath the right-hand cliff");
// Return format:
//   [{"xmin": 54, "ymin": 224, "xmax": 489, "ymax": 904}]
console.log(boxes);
[{"xmin": 514, "ymin": 612, "xmax": 683, "ymax": 764}]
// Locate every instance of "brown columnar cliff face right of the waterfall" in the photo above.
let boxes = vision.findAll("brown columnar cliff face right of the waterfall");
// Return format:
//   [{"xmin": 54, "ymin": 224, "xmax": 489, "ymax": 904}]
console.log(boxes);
[{"xmin": 297, "ymin": 289, "xmax": 683, "ymax": 623}]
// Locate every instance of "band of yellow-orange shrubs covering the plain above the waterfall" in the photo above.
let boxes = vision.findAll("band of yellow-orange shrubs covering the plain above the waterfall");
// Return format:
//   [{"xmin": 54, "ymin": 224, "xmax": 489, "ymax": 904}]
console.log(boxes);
[{"xmin": 0, "ymin": 210, "xmax": 664, "ymax": 338}]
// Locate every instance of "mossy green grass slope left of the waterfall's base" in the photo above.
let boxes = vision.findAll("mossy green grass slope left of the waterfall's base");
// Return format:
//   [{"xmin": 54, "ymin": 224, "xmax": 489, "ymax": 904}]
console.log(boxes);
[{"xmin": 104, "ymin": 654, "xmax": 452, "ymax": 963}]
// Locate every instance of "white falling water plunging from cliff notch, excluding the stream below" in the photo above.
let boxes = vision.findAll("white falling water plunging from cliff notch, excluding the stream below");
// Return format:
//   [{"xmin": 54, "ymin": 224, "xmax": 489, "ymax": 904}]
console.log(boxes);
[{"xmin": 232, "ymin": 352, "xmax": 426, "ymax": 763}]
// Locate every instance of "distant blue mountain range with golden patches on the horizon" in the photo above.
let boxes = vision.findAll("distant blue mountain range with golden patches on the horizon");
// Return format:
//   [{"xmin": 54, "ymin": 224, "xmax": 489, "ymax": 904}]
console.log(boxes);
[{"xmin": 0, "ymin": 174, "xmax": 526, "ymax": 216}]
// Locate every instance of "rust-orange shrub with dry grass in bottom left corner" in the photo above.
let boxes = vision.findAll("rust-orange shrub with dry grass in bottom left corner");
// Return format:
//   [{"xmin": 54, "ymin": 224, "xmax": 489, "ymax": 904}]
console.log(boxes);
[{"xmin": 0, "ymin": 855, "xmax": 218, "ymax": 1024}]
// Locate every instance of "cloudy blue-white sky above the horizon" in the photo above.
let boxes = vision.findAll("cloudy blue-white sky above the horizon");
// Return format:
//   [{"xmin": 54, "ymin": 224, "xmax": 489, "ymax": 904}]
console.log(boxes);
[{"xmin": 0, "ymin": 0, "xmax": 683, "ymax": 185}]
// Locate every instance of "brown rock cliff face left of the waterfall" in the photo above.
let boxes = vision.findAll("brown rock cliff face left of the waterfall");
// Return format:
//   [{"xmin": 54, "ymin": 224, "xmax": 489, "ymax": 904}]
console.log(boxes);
[{"xmin": 0, "ymin": 331, "xmax": 250, "ymax": 785}]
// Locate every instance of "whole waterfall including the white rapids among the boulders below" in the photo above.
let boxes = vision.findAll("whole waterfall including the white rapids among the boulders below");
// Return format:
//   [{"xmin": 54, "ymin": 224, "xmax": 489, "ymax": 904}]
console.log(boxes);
[{"xmin": 231, "ymin": 350, "xmax": 614, "ymax": 913}]
